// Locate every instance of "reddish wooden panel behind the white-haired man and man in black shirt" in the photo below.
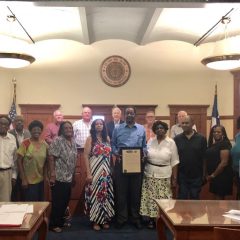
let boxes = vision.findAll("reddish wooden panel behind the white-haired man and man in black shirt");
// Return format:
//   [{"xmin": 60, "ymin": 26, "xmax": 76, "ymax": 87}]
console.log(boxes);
[{"xmin": 168, "ymin": 105, "xmax": 209, "ymax": 136}]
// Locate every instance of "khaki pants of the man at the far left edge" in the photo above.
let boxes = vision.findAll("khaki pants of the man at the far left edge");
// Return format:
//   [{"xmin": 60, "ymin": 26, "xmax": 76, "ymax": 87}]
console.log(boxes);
[{"xmin": 0, "ymin": 169, "xmax": 12, "ymax": 202}]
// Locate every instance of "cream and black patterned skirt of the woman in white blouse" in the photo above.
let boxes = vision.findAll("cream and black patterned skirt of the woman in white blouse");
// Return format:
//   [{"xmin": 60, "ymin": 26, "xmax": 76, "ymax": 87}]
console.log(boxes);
[{"xmin": 140, "ymin": 176, "xmax": 172, "ymax": 218}]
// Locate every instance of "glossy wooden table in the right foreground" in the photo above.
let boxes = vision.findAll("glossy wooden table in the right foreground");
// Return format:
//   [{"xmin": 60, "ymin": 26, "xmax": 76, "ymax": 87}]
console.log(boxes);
[{"xmin": 156, "ymin": 200, "xmax": 240, "ymax": 240}]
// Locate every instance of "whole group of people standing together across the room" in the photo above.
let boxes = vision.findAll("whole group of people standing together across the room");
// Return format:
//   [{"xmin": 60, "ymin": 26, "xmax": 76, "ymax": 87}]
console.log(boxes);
[{"xmin": 0, "ymin": 106, "xmax": 240, "ymax": 232}]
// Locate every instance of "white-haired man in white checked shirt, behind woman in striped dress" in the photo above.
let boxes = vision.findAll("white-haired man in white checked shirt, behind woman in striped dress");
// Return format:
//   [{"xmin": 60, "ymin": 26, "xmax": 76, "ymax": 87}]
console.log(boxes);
[{"xmin": 73, "ymin": 107, "xmax": 92, "ymax": 149}]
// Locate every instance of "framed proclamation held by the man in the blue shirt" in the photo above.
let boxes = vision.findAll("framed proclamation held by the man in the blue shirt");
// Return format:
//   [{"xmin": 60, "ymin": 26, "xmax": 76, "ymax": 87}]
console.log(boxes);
[{"xmin": 121, "ymin": 147, "xmax": 142, "ymax": 173}]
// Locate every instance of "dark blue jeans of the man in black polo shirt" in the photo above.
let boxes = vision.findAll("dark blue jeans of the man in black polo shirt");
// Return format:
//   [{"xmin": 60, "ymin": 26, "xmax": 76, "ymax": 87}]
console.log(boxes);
[{"xmin": 178, "ymin": 173, "xmax": 203, "ymax": 200}]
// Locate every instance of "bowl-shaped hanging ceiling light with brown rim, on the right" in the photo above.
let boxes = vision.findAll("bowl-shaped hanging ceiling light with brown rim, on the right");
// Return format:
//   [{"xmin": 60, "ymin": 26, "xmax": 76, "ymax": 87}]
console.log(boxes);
[{"xmin": 201, "ymin": 17, "xmax": 240, "ymax": 70}]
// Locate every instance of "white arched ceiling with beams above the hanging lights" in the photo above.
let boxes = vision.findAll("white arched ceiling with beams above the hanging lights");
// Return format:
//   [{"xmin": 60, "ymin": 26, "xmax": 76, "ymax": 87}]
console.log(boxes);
[{"xmin": 0, "ymin": 0, "xmax": 240, "ymax": 45}]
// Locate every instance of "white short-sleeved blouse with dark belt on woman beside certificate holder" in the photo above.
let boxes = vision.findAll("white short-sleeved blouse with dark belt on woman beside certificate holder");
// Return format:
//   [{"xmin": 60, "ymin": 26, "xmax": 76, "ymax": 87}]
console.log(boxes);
[{"xmin": 144, "ymin": 136, "xmax": 179, "ymax": 178}]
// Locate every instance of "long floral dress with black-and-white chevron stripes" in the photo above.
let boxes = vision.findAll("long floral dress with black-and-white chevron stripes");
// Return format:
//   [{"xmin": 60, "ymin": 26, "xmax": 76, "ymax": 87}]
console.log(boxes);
[{"xmin": 85, "ymin": 142, "xmax": 114, "ymax": 224}]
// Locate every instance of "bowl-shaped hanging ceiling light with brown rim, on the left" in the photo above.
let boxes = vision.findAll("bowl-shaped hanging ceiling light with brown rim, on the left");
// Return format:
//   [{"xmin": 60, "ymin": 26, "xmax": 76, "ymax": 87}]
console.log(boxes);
[{"xmin": 0, "ymin": 7, "xmax": 35, "ymax": 68}]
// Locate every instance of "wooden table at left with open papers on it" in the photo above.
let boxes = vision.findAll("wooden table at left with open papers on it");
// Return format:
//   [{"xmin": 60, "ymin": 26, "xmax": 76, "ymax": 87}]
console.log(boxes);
[{"xmin": 0, "ymin": 202, "xmax": 50, "ymax": 240}]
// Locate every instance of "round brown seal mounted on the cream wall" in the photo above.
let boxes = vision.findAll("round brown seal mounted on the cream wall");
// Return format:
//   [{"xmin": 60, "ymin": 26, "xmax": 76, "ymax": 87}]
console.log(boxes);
[{"xmin": 100, "ymin": 55, "xmax": 131, "ymax": 87}]
